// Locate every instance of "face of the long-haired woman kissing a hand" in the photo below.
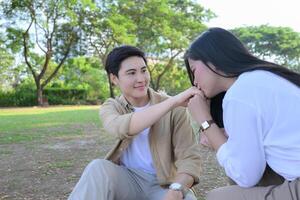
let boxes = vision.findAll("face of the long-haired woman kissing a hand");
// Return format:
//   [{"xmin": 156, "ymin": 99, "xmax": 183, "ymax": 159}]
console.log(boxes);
[{"xmin": 188, "ymin": 59, "xmax": 221, "ymax": 98}]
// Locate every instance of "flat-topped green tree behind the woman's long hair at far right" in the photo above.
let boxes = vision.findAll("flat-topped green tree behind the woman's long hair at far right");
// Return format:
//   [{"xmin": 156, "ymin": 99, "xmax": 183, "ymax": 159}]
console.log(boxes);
[{"xmin": 232, "ymin": 25, "xmax": 300, "ymax": 72}]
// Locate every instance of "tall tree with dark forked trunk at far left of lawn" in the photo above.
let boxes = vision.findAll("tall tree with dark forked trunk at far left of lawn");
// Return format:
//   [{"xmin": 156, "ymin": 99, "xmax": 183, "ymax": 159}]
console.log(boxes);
[{"xmin": 1, "ymin": 0, "xmax": 78, "ymax": 106}]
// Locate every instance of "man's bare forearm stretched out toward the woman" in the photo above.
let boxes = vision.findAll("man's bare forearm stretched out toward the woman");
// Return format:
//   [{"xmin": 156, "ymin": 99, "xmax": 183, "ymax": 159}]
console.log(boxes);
[{"xmin": 129, "ymin": 98, "xmax": 176, "ymax": 135}]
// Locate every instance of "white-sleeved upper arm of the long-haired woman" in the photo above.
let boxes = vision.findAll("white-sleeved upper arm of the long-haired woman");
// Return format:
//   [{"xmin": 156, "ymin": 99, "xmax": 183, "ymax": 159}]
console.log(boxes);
[{"xmin": 217, "ymin": 100, "xmax": 266, "ymax": 187}]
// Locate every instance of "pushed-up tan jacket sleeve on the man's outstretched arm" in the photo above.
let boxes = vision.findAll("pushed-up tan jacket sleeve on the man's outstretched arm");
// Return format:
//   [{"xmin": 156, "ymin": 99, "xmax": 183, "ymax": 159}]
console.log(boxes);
[{"xmin": 99, "ymin": 98, "xmax": 133, "ymax": 139}]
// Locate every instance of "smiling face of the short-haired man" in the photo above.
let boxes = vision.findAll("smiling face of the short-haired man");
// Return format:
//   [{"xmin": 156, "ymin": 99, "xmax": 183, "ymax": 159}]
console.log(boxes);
[{"xmin": 111, "ymin": 56, "xmax": 150, "ymax": 106}]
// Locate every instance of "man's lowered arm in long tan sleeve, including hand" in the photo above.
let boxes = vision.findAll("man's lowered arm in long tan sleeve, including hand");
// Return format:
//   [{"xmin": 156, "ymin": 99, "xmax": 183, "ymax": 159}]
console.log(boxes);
[{"xmin": 165, "ymin": 108, "xmax": 201, "ymax": 200}]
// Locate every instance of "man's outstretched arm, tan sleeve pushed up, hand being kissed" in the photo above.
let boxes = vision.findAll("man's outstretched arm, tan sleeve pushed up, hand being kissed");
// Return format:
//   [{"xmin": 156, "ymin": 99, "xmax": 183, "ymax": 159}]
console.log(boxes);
[{"xmin": 100, "ymin": 87, "xmax": 199, "ymax": 139}]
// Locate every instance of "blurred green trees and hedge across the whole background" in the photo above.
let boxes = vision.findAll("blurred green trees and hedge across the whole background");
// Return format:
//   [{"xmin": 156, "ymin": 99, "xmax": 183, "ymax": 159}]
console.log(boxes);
[{"xmin": 0, "ymin": 0, "xmax": 300, "ymax": 107}]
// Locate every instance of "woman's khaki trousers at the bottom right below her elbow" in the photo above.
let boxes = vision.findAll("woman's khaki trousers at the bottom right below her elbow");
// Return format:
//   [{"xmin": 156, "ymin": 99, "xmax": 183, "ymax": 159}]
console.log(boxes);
[{"xmin": 206, "ymin": 166, "xmax": 300, "ymax": 200}]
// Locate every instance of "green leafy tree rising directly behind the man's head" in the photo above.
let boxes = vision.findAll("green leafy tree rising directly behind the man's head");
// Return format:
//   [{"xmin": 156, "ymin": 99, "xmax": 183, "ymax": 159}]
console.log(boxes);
[{"xmin": 81, "ymin": 0, "xmax": 136, "ymax": 97}]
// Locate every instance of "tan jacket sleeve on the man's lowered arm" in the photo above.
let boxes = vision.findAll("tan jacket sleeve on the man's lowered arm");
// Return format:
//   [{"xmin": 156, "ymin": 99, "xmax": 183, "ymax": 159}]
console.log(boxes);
[{"xmin": 172, "ymin": 107, "xmax": 201, "ymax": 184}]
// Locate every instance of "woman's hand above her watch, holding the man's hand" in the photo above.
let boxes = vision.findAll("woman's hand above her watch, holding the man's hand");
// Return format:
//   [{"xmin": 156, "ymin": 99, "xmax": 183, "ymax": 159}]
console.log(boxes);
[{"xmin": 188, "ymin": 91, "xmax": 212, "ymax": 124}]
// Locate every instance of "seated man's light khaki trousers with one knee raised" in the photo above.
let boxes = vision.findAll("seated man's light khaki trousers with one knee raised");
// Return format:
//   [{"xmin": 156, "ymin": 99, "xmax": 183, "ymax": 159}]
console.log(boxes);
[{"xmin": 69, "ymin": 159, "xmax": 196, "ymax": 200}]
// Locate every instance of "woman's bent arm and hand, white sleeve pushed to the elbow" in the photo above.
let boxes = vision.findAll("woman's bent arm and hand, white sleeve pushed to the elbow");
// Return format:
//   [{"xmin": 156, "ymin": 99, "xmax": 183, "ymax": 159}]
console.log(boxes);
[{"xmin": 188, "ymin": 95, "xmax": 266, "ymax": 187}]
